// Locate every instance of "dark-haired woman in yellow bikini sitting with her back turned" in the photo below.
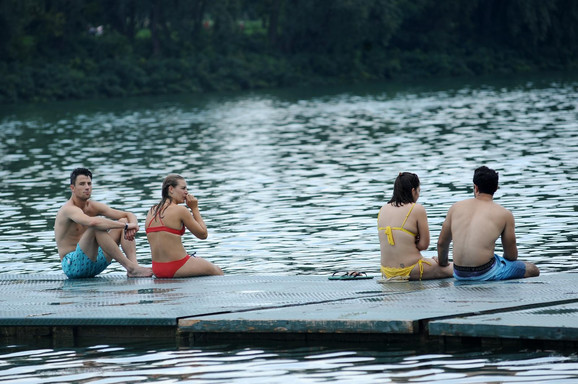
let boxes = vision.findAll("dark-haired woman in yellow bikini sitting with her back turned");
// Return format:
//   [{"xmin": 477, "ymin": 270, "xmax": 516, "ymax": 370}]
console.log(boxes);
[{"xmin": 377, "ymin": 172, "xmax": 453, "ymax": 281}]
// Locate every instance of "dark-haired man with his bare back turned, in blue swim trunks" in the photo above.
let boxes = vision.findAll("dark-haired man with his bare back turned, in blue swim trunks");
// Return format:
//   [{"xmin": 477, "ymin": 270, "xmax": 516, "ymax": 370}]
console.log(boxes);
[{"xmin": 438, "ymin": 166, "xmax": 540, "ymax": 281}]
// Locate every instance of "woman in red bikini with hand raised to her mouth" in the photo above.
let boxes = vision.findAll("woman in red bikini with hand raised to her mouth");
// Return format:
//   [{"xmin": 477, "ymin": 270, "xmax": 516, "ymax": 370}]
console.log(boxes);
[{"xmin": 145, "ymin": 175, "xmax": 223, "ymax": 278}]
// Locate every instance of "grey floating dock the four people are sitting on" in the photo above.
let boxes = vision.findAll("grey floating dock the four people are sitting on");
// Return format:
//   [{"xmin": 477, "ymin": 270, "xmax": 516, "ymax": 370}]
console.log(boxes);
[{"xmin": 0, "ymin": 273, "xmax": 578, "ymax": 347}]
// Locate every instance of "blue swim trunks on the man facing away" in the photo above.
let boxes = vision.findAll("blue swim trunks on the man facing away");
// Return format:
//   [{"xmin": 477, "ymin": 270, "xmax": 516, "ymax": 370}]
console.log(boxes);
[{"xmin": 454, "ymin": 255, "xmax": 526, "ymax": 281}]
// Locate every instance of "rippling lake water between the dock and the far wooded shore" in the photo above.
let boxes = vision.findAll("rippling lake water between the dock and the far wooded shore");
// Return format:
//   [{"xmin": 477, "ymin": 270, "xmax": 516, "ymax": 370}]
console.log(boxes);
[{"xmin": 0, "ymin": 75, "xmax": 578, "ymax": 274}]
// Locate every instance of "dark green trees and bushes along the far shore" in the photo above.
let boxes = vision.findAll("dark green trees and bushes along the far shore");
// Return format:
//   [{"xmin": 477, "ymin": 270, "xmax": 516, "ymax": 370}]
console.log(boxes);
[{"xmin": 0, "ymin": 0, "xmax": 578, "ymax": 104}]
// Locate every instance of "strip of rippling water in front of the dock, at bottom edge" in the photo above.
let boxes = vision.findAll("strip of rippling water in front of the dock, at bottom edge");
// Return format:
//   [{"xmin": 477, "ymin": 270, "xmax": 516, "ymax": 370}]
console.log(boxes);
[{"xmin": 0, "ymin": 343, "xmax": 578, "ymax": 383}]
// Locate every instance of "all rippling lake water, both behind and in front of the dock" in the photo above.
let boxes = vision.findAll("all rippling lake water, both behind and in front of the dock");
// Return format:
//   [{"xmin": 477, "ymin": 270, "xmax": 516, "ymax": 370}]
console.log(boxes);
[{"xmin": 0, "ymin": 75, "xmax": 578, "ymax": 383}]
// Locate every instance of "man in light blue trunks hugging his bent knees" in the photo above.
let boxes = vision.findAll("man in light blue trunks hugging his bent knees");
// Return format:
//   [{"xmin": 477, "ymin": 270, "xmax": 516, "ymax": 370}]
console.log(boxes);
[{"xmin": 54, "ymin": 168, "xmax": 153, "ymax": 278}]
